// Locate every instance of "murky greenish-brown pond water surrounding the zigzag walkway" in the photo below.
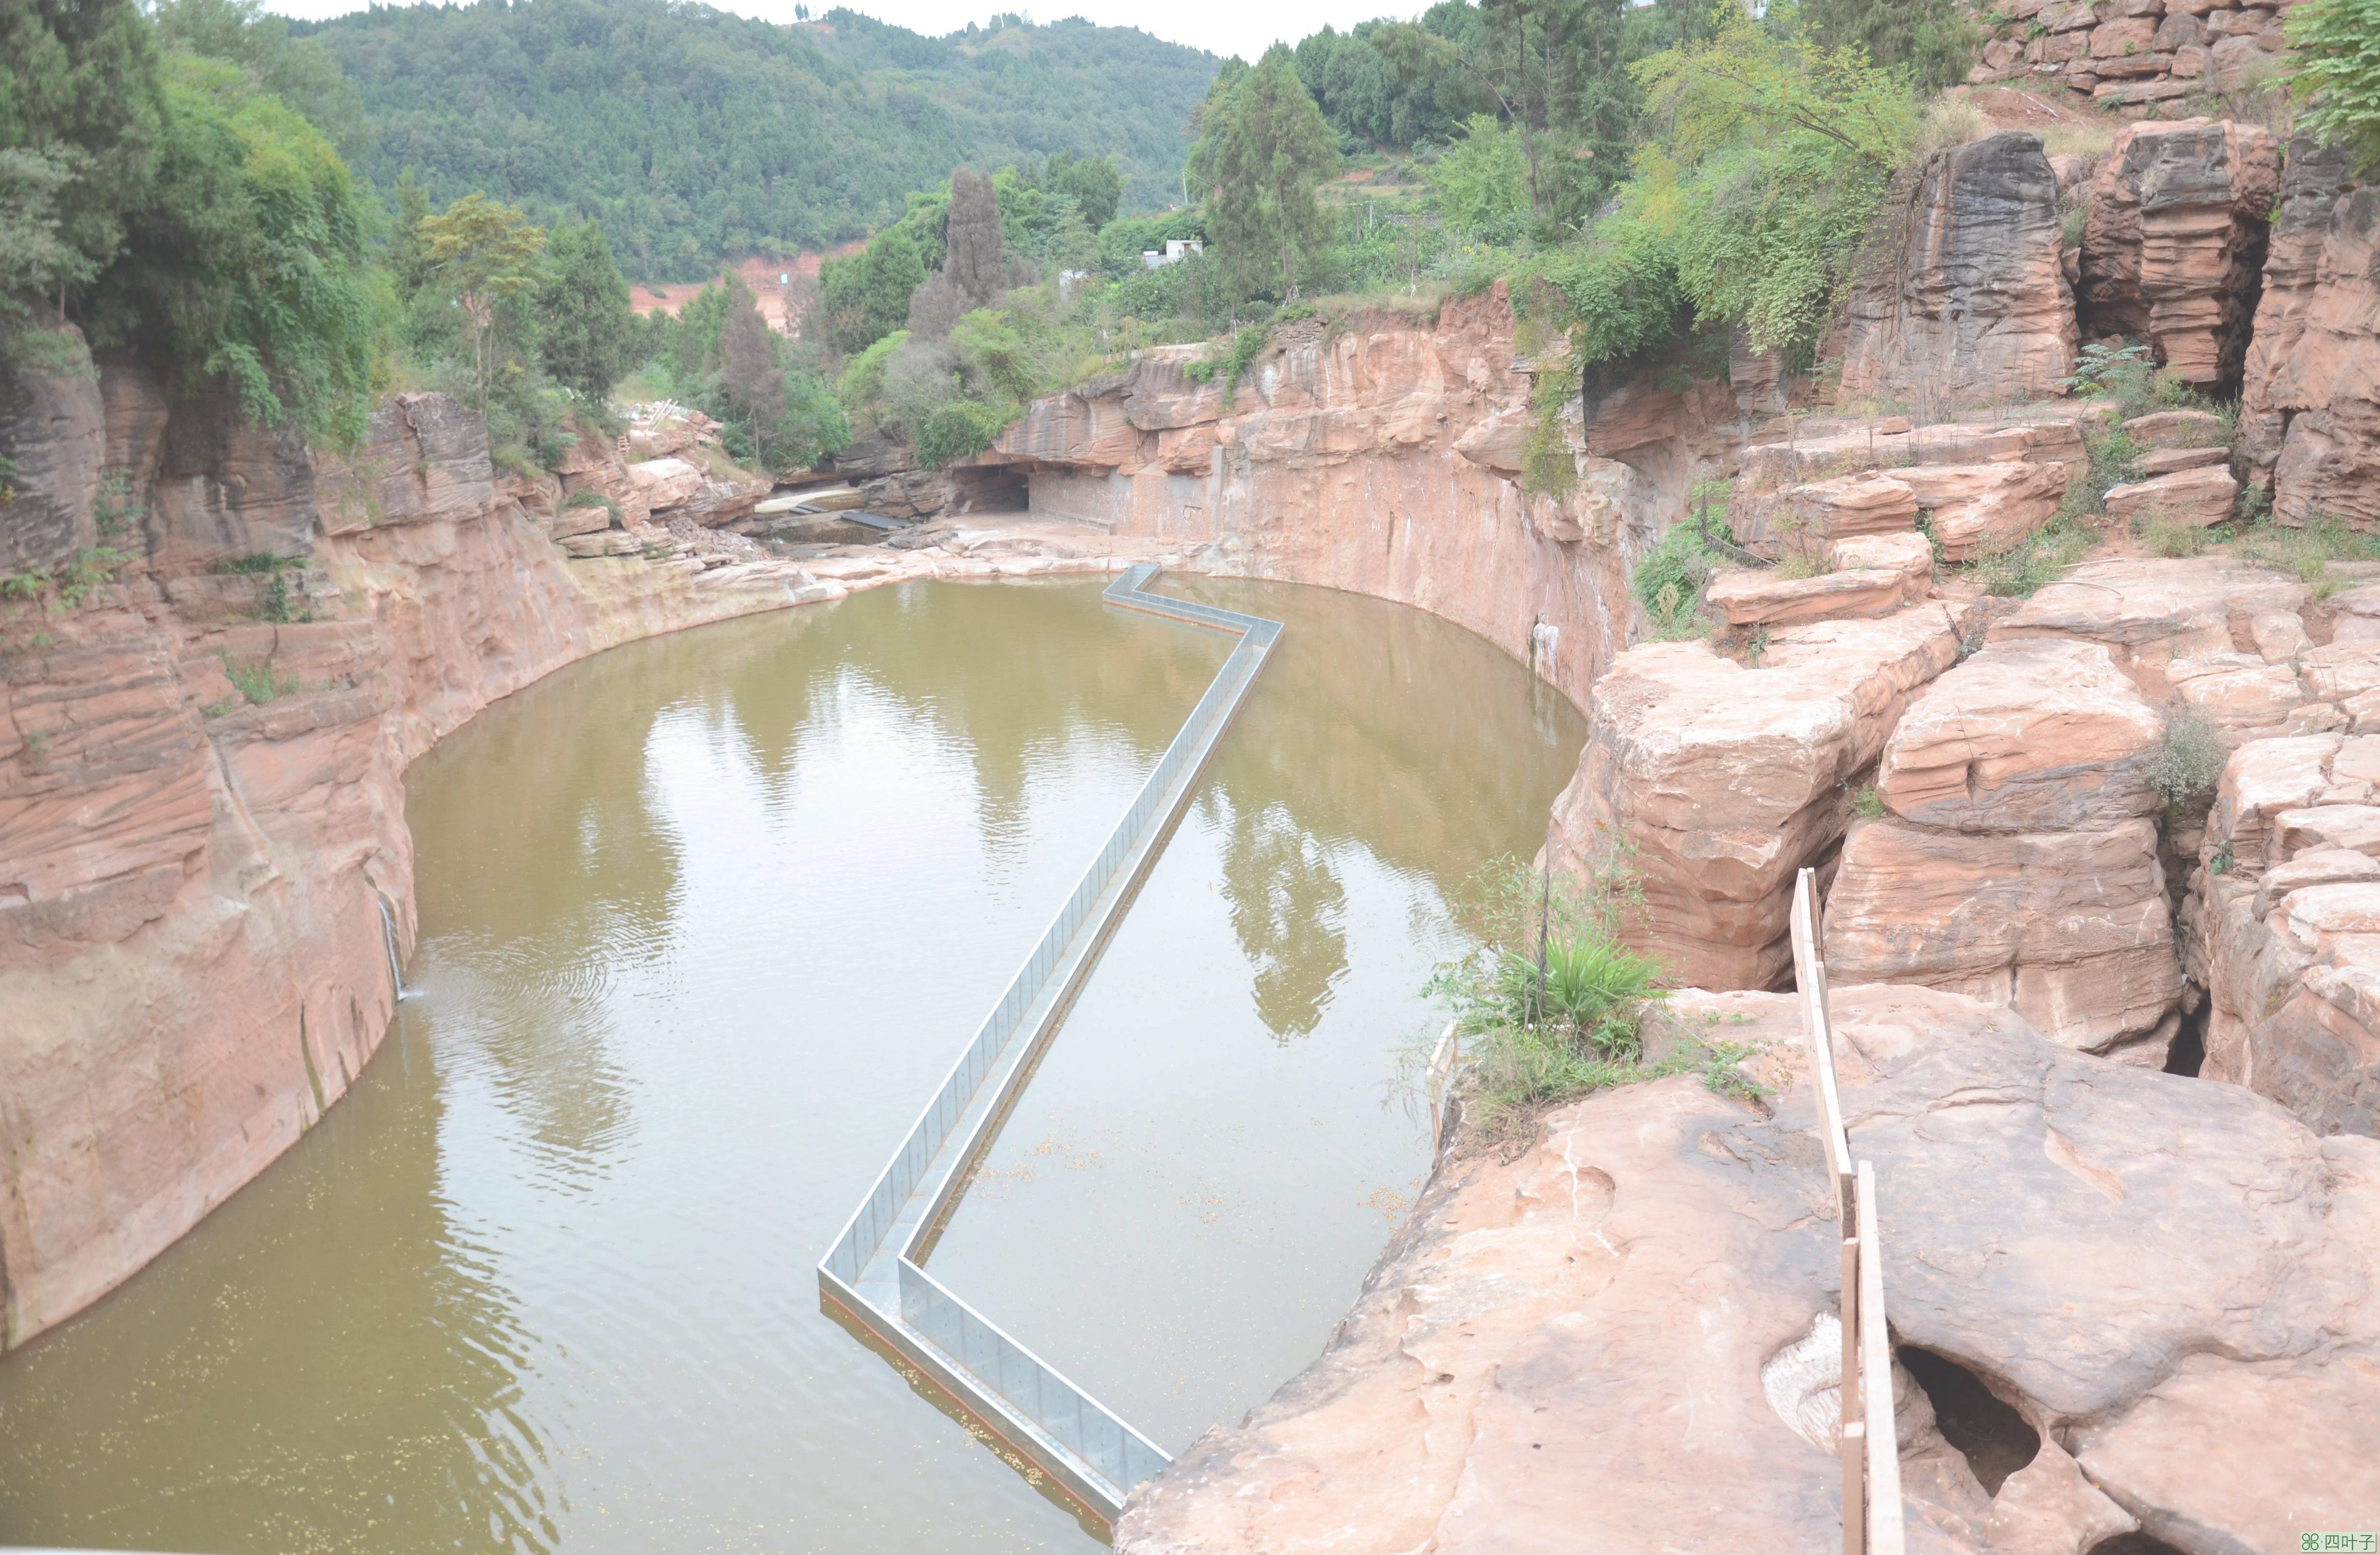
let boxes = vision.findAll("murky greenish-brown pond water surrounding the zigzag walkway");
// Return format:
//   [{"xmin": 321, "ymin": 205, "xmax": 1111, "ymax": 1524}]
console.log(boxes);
[{"xmin": 0, "ymin": 584, "xmax": 1583, "ymax": 1555}]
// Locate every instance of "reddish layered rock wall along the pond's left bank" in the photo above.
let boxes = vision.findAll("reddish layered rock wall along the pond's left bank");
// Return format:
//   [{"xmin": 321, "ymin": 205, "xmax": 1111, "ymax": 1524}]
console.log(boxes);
[{"xmin": 0, "ymin": 364, "xmax": 819, "ymax": 1345}]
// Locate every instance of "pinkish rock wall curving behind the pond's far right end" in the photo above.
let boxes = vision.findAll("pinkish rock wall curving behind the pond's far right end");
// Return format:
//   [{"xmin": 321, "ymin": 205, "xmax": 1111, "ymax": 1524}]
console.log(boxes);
[{"xmin": 988, "ymin": 286, "xmax": 1740, "ymax": 705}]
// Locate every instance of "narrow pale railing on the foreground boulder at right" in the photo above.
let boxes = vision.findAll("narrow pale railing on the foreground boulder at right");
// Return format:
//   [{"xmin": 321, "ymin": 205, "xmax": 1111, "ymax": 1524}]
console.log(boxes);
[{"xmin": 1792, "ymin": 869, "xmax": 1901, "ymax": 1555}]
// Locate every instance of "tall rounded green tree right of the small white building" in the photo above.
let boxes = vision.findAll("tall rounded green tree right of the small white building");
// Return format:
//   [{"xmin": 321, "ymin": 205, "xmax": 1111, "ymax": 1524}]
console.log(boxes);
[{"xmin": 1190, "ymin": 45, "xmax": 1340, "ymax": 300}]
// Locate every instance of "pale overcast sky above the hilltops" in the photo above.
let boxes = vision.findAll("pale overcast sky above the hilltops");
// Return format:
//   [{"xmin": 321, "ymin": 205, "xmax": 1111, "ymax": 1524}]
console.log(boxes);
[{"xmin": 267, "ymin": 0, "xmax": 1389, "ymax": 59}]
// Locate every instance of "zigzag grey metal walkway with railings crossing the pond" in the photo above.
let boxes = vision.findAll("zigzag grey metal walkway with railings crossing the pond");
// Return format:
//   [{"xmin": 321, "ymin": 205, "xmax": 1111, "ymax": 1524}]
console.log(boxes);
[{"xmin": 819, "ymin": 564, "xmax": 1280, "ymax": 1522}]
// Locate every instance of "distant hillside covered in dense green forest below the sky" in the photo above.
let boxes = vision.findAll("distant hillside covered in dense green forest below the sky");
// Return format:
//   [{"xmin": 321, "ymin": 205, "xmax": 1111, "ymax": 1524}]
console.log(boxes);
[{"xmin": 290, "ymin": 0, "xmax": 1216, "ymax": 279}]
